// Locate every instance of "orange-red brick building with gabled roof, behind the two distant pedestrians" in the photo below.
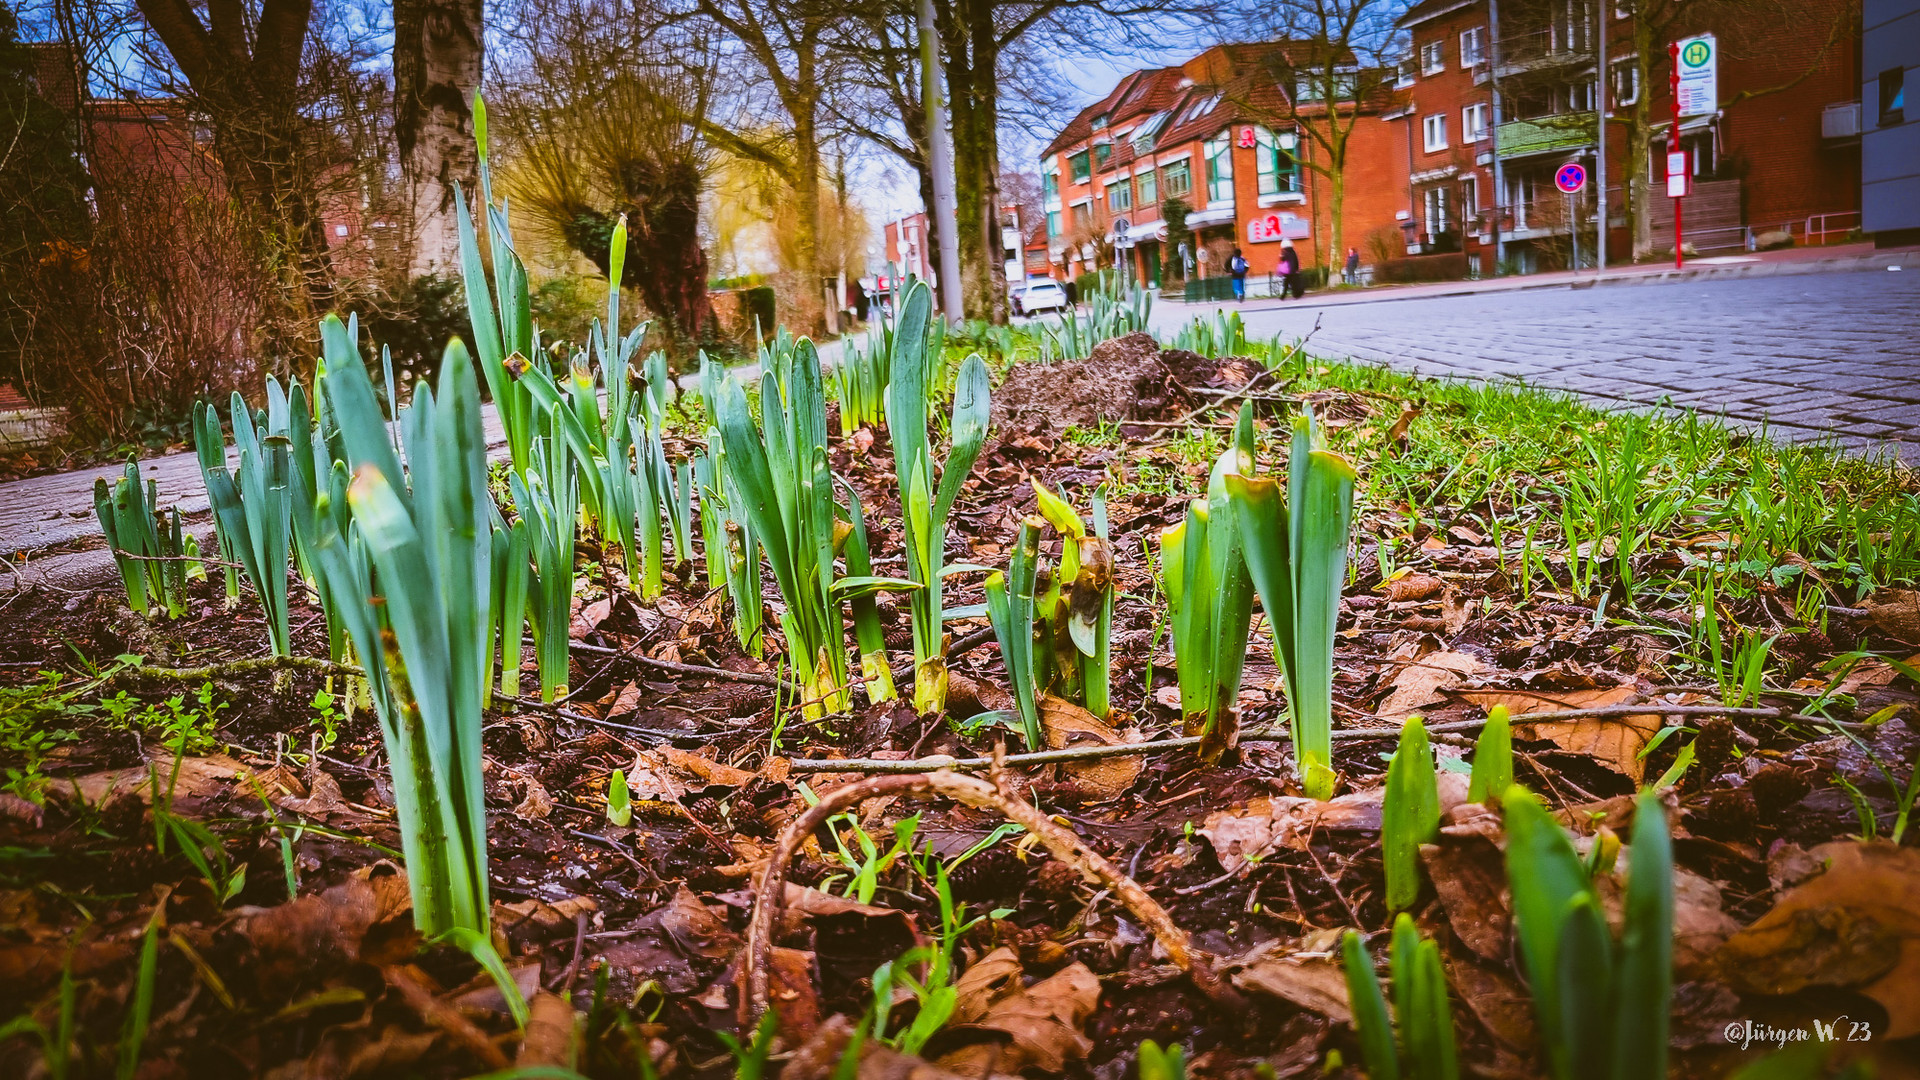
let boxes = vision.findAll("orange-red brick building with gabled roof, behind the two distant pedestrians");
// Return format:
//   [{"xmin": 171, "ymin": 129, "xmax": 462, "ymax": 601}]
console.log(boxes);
[{"xmin": 1041, "ymin": 42, "xmax": 1400, "ymax": 284}]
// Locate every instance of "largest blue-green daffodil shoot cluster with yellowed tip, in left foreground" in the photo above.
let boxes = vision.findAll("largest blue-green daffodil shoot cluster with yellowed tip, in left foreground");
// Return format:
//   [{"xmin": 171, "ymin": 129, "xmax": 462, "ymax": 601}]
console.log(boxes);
[{"xmin": 296, "ymin": 315, "xmax": 492, "ymax": 940}]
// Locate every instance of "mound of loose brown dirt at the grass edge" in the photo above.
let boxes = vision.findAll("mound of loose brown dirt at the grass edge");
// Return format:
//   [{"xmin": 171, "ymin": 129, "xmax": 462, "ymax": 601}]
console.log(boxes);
[{"xmin": 993, "ymin": 332, "xmax": 1260, "ymax": 434}]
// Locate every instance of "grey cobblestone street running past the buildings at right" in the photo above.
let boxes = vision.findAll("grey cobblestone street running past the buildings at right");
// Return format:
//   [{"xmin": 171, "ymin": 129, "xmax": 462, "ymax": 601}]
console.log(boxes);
[{"xmin": 1154, "ymin": 267, "xmax": 1920, "ymax": 463}]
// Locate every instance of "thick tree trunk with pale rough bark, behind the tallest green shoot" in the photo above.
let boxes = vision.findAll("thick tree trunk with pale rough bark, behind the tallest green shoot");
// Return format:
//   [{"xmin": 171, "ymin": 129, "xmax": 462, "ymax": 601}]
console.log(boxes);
[{"xmin": 394, "ymin": 0, "xmax": 486, "ymax": 275}]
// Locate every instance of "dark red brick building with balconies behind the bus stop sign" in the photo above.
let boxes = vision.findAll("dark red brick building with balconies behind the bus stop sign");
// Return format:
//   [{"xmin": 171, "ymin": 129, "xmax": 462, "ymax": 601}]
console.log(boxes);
[{"xmin": 1396, "ymin": 0, "xmax": 1860, "ymax": 273}]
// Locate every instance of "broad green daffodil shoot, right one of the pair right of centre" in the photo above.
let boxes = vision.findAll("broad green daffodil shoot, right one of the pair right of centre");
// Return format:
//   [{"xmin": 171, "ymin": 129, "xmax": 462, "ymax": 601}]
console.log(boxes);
[{"xmin": 1225, "ymin": 403, "xmax": 1356, "ymax": 799}]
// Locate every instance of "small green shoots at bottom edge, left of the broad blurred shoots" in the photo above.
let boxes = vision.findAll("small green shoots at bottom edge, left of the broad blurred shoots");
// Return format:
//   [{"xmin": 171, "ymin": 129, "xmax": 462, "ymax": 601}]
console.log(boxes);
[{"xmin": 1340, "ymin": 911, "xmax": 1459, "ymax": 1080}]
